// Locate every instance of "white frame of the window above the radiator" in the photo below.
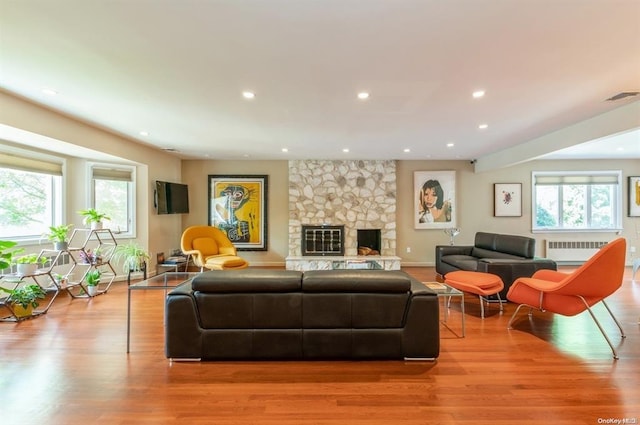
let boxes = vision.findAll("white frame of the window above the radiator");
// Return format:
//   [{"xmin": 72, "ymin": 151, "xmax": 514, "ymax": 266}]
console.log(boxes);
[{"xmin": 531, "ymin": 170, "xmax": 623, "ymax": 233}]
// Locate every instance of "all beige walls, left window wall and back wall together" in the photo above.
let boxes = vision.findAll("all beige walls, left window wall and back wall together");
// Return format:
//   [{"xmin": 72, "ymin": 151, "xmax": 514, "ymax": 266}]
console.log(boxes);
[{"xmin": 0, "ymin": 92, "xmax": 640, "ymax": 266}]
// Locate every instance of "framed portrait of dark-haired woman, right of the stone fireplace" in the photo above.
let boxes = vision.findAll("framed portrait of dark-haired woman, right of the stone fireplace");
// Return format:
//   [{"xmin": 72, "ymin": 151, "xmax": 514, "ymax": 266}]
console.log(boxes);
[{"xmin": 413, "ymin": 171, "xmax": 456, "ymax": 229}]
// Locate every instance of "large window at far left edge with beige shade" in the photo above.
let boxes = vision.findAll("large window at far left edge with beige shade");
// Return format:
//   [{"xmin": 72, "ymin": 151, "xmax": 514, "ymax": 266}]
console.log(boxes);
[{"xmin": 0, "ymin": 152, "xmax": 62, "ymax": 242}]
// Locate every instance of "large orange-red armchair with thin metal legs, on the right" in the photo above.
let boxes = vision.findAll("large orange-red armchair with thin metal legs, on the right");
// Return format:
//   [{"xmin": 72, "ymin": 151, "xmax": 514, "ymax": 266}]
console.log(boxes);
[{"xmin": 507, "ymin": 238, "xmax": 627, "ymax": 359}]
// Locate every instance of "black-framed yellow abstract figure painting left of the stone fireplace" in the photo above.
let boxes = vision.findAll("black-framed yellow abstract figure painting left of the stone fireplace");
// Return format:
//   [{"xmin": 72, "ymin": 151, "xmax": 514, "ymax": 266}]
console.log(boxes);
[{"xmin": 209, "ymin": 175, "xmax": 268, "ymax": 251}]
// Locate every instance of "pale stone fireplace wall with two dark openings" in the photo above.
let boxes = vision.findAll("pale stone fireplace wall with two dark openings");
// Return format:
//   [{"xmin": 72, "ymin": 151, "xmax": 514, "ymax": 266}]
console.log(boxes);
[{"xmin": 287, "ymin": 160, "xmax": 399, "ymax": 268}]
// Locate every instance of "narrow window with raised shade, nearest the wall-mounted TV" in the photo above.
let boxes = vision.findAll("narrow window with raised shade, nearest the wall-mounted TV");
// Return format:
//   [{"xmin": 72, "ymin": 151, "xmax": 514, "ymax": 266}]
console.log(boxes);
[{"xmin": 89, "ymin": 164, "xmax": 135, "ymax": 237}]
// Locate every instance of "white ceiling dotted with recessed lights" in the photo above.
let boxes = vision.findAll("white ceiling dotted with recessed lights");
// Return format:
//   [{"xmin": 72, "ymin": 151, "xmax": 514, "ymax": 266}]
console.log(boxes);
[{"xmin": 0, "ymin": 0, "xmax": 640, "ymax": 160}]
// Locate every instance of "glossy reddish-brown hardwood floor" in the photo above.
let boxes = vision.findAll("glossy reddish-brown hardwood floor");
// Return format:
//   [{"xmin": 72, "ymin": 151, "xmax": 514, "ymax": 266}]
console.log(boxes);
[{"xmin": 0, "ymin": 268, "xmax": 640, "ymax": 425}]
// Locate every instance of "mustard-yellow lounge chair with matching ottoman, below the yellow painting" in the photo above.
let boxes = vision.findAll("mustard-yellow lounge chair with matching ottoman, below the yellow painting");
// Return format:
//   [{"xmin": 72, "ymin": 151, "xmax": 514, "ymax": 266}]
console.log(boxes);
[{"xmin": 180, "ymin": 226, "xmax": 249, "ymax": 271}]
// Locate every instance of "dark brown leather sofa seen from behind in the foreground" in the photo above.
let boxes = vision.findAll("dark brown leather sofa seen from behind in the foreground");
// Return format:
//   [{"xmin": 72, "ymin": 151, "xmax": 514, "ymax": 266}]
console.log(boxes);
[{"xmin": 165, "ymin": 268, "xmax": 440, "ymax": 360}]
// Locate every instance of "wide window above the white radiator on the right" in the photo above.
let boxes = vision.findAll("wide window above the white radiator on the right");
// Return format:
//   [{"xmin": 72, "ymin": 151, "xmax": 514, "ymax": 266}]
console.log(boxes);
[{"xmin": 531, "ymin": 171, "xmax": 622, "ymax": 231}]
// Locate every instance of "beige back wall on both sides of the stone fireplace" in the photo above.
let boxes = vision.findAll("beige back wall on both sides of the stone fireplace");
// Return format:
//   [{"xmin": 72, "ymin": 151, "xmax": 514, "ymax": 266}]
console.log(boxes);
[{"xmin": 182, "ymin": 160, "xmax": 640, "ymax": 266}]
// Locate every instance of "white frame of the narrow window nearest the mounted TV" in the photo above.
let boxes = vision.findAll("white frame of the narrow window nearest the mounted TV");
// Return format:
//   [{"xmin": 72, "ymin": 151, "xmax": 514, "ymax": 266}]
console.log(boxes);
[{"xmin": 87, "ymin": 161, "xmax": 137, "ymax": 239}]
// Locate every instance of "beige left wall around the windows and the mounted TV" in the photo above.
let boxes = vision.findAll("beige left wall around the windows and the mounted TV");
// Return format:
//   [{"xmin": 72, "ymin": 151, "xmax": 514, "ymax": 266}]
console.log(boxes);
[{"xmin": 0, "ymin": 92, "xmax": 182, "ymax": 270}]
